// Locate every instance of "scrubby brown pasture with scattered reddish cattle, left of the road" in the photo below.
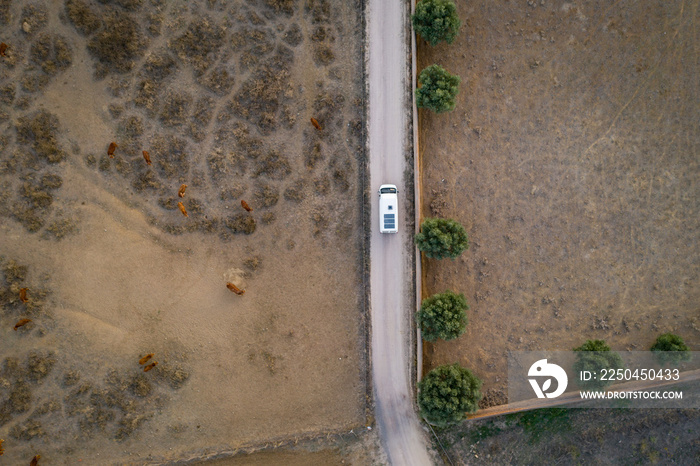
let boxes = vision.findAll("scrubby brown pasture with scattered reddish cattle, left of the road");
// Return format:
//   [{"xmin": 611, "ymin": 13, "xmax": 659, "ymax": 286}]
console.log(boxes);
[{"xmin": 0, "ymin": 0, "xmax": 368, "ymax": 464}]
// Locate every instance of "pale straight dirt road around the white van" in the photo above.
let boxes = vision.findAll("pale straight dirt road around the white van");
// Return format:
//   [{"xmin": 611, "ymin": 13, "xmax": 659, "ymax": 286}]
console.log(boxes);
[{"xmin": 367, "ymin": 0, "xmax": 431, "ymax": 465}]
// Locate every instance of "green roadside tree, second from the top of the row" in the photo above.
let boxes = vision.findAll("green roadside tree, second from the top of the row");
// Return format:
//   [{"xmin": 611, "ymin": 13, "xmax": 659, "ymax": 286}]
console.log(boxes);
[{"xmin": 416, "ymin": 65, "xmax": 462, "ymax": 113}]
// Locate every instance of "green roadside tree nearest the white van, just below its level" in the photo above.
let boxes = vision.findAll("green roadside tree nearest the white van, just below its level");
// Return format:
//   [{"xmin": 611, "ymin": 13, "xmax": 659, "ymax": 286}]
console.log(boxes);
[{"xmin": 416, "ymin": 218, "xmax": 469, "ymax": 259}]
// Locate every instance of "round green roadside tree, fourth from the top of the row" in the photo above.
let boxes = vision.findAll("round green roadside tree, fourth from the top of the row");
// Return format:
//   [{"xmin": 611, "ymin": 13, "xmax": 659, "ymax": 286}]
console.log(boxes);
[{"xmin": 416, "ymin": 290, "xmax": 469, "ymax": 341}]
